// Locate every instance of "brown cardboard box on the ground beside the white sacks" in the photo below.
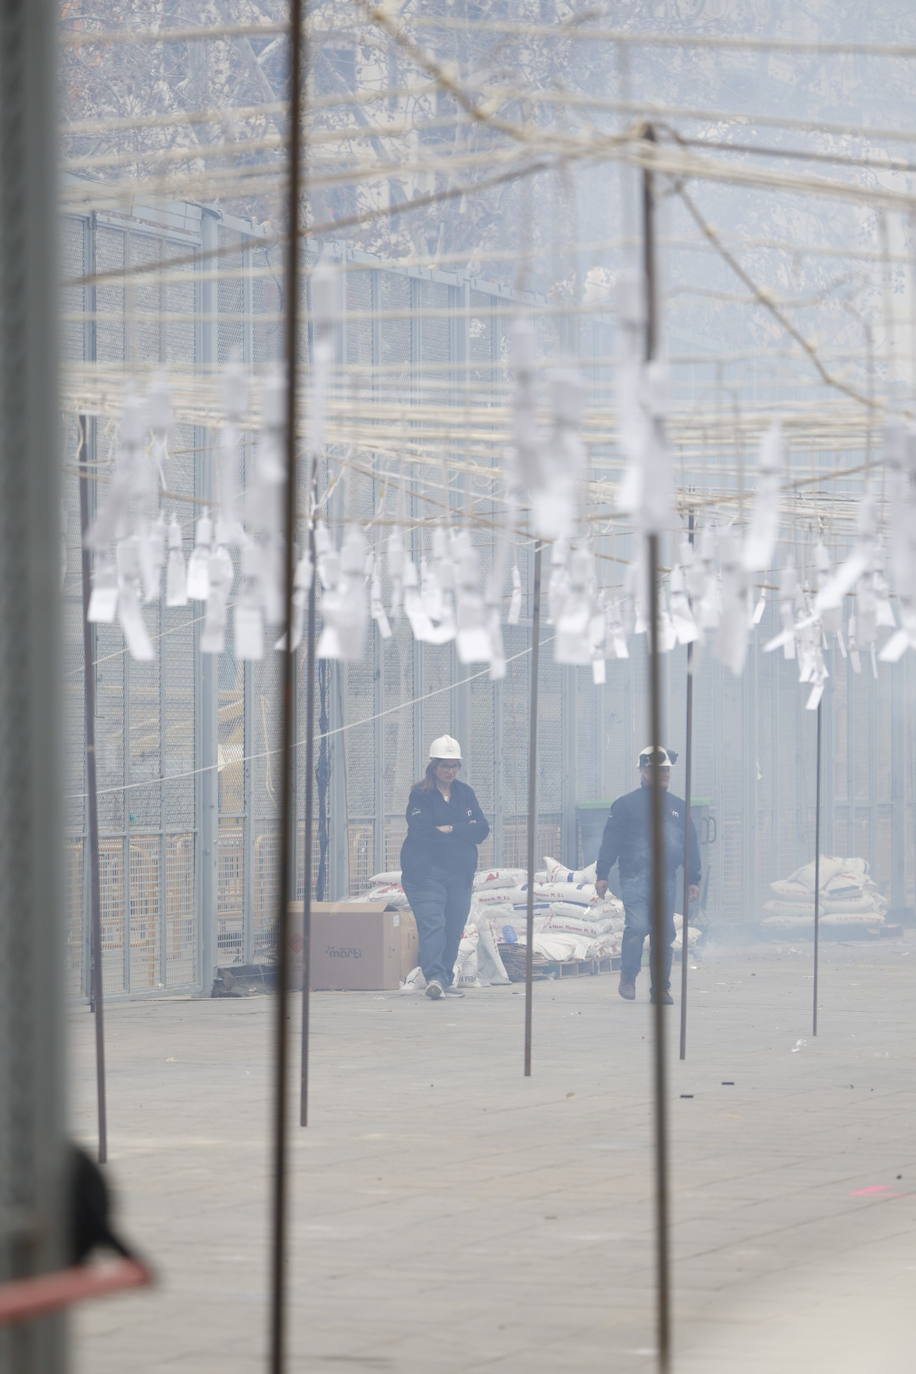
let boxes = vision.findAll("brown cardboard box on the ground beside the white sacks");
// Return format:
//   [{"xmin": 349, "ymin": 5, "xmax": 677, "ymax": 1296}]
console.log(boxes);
[{"xmin": 290, "ymin": 901, "xmax": 416, "ymax": 992}]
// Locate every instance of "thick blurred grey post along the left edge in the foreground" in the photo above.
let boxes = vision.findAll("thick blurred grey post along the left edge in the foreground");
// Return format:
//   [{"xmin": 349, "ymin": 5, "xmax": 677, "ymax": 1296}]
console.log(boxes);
[{"xmin": 0, "ymin": 0, "xmax": 67, "ymax": 1374}]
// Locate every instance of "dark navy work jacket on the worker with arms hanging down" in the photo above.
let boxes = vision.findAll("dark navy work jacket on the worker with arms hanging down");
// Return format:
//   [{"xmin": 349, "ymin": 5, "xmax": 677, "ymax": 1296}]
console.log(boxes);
[{"xmin": 595, "ymin": 787, "xmax": 700, "ymax": 883}]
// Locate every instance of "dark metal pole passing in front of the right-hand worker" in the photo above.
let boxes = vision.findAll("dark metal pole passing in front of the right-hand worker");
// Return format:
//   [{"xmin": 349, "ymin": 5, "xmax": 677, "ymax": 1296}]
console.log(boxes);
[{"xmin": 643, "ymin": 125, "xmax": 672, "ymax": 1374}]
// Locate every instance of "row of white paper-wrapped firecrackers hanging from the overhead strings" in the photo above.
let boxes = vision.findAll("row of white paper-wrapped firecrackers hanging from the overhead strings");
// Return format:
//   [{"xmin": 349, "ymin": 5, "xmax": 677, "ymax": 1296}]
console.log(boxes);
[{"xmin": 76, "ymin": 357, "xmax": 916, "ymax": 692}]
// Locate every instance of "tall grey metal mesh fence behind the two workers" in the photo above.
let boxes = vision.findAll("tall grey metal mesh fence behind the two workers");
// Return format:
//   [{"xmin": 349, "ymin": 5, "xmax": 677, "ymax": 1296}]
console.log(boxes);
[{"xmin": 63, "ymin": 196, "xmax": 916, "ymax": 995}]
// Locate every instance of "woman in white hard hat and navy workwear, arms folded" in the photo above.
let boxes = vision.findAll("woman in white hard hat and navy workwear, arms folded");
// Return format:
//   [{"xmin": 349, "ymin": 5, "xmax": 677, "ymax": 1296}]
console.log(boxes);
[{"xmin": 401, "ymin": 735, "xmax": 490, "ymax": 1002}]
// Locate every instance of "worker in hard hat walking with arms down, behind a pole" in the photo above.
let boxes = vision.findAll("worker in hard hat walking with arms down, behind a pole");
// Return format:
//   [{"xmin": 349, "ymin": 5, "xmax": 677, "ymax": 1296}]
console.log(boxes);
[{"xmin": 595, "ymin": 745, "xmax": 700, "ymax": 1006}]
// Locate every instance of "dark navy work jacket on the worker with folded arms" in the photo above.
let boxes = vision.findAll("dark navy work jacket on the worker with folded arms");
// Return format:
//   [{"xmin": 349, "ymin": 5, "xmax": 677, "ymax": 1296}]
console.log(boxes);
[{"xmin": 401, "ymin": 779, "xmax": 490, "ymax": 882}]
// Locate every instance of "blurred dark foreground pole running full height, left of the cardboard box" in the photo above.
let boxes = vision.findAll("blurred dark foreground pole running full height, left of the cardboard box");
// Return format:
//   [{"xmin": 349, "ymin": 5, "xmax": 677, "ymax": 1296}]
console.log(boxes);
[{"xmin": 269, "ymin": 0, "xmax": 306, "ymax": 1374}]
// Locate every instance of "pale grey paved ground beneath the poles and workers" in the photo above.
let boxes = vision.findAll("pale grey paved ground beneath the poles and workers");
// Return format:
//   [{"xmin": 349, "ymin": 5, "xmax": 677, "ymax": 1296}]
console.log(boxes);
[{"xmin": 73, "ymin": 940, "xmax": 916, "ymax": 1374}]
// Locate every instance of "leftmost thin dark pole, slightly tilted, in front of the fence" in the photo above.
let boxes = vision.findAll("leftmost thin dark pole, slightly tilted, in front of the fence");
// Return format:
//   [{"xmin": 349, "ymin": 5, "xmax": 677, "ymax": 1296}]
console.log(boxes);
[{"xmin": 77, "ymin": 415, "xmax": 108, "ymax": 1164}]
